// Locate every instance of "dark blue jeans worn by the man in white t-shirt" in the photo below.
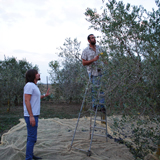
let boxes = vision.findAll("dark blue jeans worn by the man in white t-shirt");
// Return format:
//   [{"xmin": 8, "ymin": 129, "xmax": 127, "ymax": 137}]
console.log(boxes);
[{"xmin": 24, "ymin": 116, "xmax": 38, "ymax": 160}]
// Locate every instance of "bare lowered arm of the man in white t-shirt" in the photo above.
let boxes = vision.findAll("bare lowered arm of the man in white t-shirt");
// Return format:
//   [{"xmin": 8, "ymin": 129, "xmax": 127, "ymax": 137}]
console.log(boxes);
[{"xmin": 24, "ymin": 94, "xmax": 36, "ymax": 127}]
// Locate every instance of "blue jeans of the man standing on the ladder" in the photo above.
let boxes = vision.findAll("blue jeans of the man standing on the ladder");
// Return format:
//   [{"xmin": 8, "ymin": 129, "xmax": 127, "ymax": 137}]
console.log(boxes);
[{"xmin": 89, "ymin": 74, "xmax": 105, "ymax": 108}]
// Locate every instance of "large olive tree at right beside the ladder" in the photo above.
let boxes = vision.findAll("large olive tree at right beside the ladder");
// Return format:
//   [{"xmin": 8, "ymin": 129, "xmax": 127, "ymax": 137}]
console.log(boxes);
[{"xmin": 85, "ymin": 0, "xmax": 160, "ymax": 158}]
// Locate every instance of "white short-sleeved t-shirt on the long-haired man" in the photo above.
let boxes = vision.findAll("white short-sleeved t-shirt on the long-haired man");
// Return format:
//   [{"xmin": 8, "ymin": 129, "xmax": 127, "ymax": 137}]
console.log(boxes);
[{"xmin": 23, "ymin": 82, "xmax": 41, "ymax": 117}]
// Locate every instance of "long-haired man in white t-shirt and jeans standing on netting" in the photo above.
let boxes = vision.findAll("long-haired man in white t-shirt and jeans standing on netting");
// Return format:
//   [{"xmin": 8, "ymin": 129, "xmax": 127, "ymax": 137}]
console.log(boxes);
[{"xmin": 23, "ymin": 69, "xmax": 49, "ymax": 160}]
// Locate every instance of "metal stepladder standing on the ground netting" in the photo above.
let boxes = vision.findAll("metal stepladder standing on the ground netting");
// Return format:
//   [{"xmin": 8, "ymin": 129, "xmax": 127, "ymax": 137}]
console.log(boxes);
[{"xmin": 70, "ymin": 75, "xmax": 108, "ymax": 156}]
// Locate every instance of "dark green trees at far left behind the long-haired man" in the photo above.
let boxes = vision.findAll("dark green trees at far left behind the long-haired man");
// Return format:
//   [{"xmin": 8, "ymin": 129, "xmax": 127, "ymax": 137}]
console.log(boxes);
[{"xmin": 0, "ymin": 57, "xmax": 38, "ymax": 111}]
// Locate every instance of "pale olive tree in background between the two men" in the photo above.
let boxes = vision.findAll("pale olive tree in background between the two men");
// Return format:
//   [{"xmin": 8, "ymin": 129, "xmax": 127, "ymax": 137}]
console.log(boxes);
[{"xmin": 49, "ymin": 38, "xmax": 86, "ymax": 102}]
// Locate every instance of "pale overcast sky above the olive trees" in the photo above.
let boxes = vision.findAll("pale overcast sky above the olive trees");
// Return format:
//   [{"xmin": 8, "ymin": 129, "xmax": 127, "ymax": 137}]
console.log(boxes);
[{"xmin": 0, "ymin": 0, "xmax": 156, "ymax": 83}]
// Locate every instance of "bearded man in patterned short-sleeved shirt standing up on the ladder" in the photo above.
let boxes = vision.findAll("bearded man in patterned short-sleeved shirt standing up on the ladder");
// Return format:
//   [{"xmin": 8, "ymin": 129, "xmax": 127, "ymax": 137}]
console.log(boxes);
[{"xmin": 81, "ymin": 34, "xmax": 105, "ymax": 112}]
